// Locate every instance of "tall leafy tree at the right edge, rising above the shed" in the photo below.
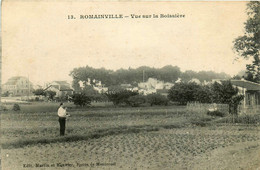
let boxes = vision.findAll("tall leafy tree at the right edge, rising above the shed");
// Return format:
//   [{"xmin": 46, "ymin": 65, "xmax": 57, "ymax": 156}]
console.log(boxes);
[{"xmin": 233, "ymin": 1, "xmax": 260, "ymax": 83}]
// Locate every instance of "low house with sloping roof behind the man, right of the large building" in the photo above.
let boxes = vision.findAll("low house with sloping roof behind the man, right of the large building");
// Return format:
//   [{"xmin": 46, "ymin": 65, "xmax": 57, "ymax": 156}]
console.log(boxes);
[{"xmin": 44, "ymin": 81, "xmax": 73, "ymax": 98}]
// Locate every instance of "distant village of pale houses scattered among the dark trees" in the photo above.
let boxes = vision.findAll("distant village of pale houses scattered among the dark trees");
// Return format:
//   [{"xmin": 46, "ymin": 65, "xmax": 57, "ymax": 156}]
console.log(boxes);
[{"xmin": 2, "ymin": 76, "xmax": 175, "ymax": 98}]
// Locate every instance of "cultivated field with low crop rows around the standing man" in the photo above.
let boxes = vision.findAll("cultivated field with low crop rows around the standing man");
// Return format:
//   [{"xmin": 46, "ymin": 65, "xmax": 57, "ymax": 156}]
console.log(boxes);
[{"xmin": 1, "ymin": 104, "xmax": 260, "ymax": 170}]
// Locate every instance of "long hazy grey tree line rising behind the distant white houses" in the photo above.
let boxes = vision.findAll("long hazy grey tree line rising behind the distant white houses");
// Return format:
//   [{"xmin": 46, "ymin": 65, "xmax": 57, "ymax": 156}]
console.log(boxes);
[{"xmin": 70, "ymin": 65, "xmax": 230, "ymax": 90}]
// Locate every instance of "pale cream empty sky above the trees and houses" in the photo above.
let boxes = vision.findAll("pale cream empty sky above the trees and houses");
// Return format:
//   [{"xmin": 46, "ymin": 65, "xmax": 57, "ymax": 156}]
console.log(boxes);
[{"xmin": 2, "ymin": 0, "xmax": 250, "ymax": 84}]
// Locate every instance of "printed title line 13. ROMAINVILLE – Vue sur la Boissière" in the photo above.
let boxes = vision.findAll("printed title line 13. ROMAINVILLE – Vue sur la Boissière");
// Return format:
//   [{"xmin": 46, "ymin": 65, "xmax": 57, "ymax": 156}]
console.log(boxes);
[{"xmin": 68, "ymin": 13, "xmax": 185, "ymax": 19}]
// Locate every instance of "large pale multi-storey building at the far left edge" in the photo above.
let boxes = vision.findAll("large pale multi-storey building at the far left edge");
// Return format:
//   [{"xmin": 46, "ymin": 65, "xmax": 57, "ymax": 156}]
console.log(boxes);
[{"xmin": 2, "ymin": 76, "xmax": 33, "ymax": 96}]
